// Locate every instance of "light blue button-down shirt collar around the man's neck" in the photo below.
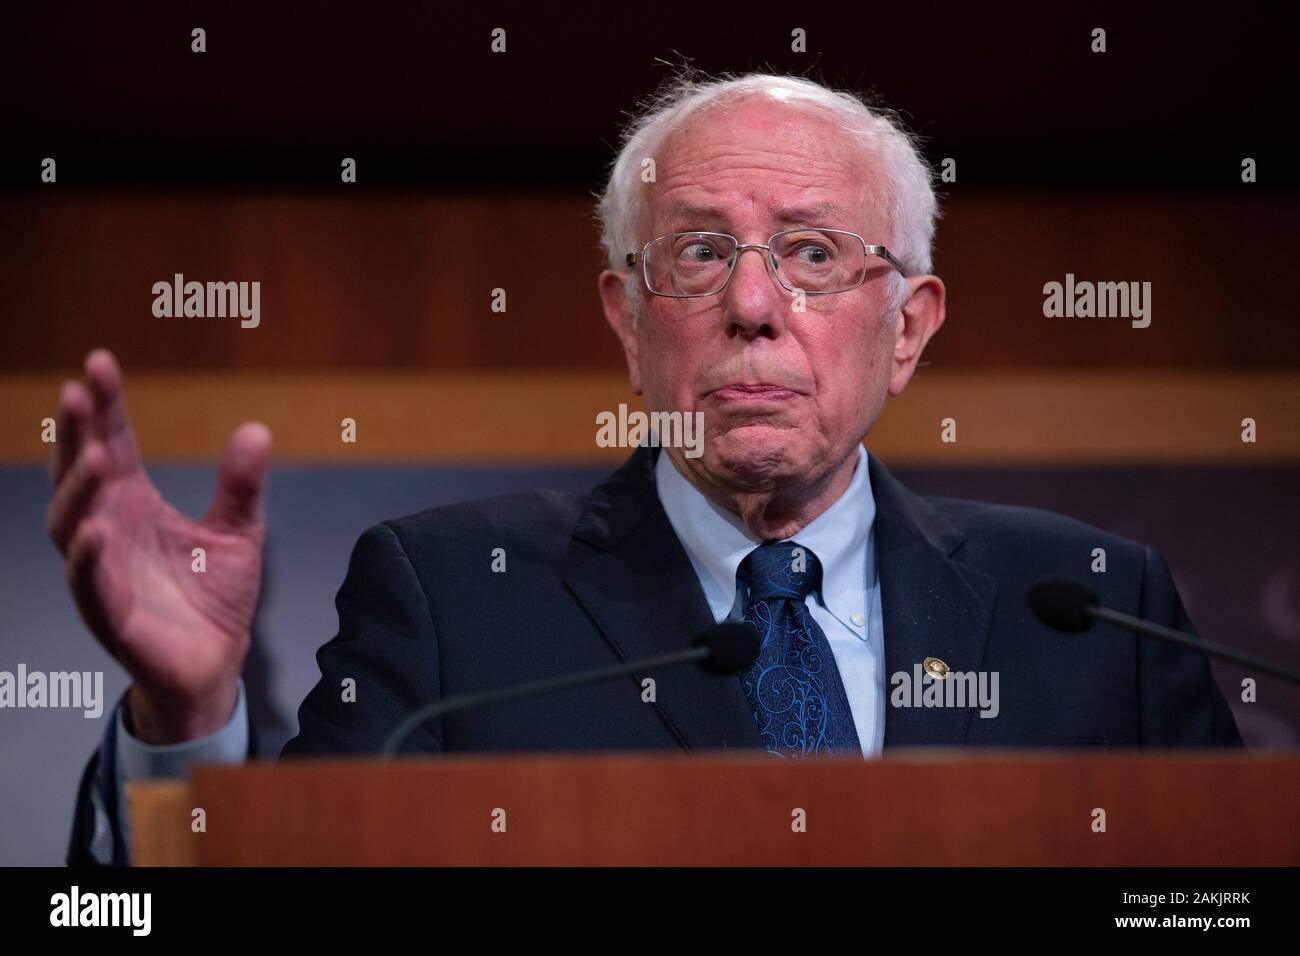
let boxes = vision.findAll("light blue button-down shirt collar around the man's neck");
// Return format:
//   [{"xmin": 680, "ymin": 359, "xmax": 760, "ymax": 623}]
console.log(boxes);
[{"xmin": 655, "ymin": 445, "xmax": 876, "ymax": 620}]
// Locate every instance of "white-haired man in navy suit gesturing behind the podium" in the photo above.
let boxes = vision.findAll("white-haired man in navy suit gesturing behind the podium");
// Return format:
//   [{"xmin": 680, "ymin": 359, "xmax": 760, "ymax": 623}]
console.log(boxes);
[{"xmin": 49, "ymin": 75, "xmax": 1240, "ymax": 862}]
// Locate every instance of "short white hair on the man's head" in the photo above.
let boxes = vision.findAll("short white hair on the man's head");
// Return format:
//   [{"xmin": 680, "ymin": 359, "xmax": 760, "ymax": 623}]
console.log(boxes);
[{"xmin": 597, "ymin": 68, "xmax": 940, "ymax": 317}]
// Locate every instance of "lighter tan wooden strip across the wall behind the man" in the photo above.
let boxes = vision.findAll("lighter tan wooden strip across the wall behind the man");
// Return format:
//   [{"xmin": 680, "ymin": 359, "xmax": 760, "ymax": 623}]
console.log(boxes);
[{"xmin": 0, "ymin": 369, "xmax": 1300, "ymax": 467}]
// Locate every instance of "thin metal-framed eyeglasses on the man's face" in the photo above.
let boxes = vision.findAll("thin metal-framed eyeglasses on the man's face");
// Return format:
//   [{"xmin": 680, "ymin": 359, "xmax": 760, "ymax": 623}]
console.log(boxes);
[{"xmin": 627, "ymin": 229, "xmax": 907, "ymax": 299}]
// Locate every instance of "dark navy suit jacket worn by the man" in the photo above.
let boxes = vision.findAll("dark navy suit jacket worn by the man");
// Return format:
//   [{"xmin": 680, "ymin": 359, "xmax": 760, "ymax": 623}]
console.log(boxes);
[{"xmin": 69, "ymin": 447, "xmax": 1242, "ymax": 862}]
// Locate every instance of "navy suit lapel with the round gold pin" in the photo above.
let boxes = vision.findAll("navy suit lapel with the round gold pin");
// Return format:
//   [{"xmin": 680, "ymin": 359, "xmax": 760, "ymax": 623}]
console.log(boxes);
[{"xmin": 870, "ymin": 455, "xmax": 997, "ymax": 748}]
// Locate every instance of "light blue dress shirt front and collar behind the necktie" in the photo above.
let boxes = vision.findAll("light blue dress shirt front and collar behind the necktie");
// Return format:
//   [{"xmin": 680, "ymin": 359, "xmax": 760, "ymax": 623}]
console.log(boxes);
[{"xmin": 655, "ymin": 445, "xmax": 885, "ymax": 757}]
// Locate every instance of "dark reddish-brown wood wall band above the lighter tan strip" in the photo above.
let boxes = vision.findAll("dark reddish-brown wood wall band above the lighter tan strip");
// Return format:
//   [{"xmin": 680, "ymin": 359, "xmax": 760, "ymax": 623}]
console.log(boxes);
[{"xmin": 0, "ymin": 192, "xmax": 1300, "ymax": 373}]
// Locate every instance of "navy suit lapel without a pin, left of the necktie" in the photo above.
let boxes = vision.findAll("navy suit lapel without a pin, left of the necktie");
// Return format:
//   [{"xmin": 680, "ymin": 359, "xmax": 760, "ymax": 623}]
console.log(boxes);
[{"xmin": 566, "ymin": 447, "xmax": 763, "ymax": 750}]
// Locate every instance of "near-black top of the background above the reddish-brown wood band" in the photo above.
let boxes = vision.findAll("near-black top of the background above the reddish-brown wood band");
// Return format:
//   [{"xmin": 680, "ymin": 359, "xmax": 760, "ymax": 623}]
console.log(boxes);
[{"xmin": 0, "ymin": 3, "xmax": 1297, "ymax": 193}]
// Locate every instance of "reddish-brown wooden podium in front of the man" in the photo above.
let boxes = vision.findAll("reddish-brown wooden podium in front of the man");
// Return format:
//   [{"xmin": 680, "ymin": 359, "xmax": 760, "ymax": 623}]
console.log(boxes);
[{"xmin": 127, "ymin": 750, "xmax": 1300, "ymax": 866}]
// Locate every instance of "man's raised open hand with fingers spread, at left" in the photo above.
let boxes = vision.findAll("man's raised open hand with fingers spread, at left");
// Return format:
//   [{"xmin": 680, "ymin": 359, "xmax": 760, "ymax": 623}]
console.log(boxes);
[{"xmin": 46, "ymin": 350, "xmax": 270, "ymax": 744}]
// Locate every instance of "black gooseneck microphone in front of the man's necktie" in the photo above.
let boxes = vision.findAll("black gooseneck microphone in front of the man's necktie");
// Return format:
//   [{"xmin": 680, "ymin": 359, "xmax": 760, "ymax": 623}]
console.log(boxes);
[{"xmin": 380, "ymin": 620, "xmax": 761, "ymax": 758}]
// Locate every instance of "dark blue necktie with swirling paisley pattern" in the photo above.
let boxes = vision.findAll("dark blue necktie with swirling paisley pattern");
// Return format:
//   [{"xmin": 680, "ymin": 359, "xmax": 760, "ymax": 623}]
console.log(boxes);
[{"xmin": 740, "ymin": 541, "xmax": 862, "ymax": 758}]
